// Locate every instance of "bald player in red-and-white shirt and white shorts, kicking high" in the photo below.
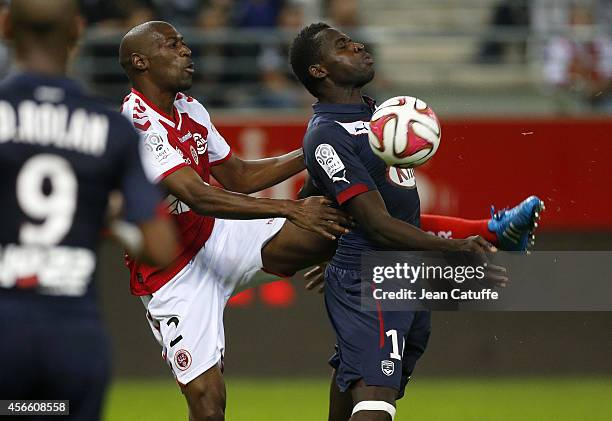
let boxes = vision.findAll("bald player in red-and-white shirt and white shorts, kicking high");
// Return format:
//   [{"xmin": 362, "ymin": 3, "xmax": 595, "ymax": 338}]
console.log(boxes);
[{"xmin": 120, "ymin": 22, "xmax": 544, "ymax": 420}]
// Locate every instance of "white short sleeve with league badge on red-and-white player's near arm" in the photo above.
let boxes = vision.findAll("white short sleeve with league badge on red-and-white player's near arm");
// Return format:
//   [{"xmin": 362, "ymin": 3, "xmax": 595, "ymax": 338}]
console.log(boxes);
[{"xmin": 141, "ymin": 131, "xmax": 187, "ymax": 183}]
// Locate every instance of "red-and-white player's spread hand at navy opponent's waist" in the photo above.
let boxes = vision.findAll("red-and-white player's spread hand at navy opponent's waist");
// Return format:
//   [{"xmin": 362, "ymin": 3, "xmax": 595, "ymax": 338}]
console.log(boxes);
[{"xmin": 287, "ymin": 196, "xmax": 354, "ymax": 240}]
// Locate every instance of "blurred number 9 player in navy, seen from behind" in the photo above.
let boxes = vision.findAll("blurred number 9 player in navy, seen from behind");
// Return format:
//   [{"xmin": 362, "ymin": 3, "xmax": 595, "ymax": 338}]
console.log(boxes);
[{"xmin": 0, "ymin": 0, "xmax": 176, "ymax": 421}]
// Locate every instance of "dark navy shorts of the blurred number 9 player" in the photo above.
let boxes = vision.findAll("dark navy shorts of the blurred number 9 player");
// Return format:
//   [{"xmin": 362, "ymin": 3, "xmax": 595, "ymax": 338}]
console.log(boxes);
[{"xmin": 0, "ymin": 290, "xmax": 110, "ymax": 421}]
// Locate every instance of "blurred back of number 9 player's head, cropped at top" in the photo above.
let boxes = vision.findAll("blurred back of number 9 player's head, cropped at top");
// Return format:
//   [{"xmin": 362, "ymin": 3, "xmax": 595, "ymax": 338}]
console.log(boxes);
[{"xmin": 7, "ymin": 0, "xmax": 79, "ymax": 43}]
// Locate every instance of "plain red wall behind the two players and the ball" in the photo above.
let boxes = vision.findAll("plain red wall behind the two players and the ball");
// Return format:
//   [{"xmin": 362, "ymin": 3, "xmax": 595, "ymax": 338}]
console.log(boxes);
[{"xmin": 217, "ymin": 118, "xmax": 612, "ymax": 231}]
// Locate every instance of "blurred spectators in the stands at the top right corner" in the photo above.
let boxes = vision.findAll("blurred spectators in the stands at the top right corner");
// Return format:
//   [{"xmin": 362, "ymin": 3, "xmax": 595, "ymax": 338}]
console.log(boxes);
[{"xmin": 479, "ymin": 0, "xmax": 612, "ymax": 113}]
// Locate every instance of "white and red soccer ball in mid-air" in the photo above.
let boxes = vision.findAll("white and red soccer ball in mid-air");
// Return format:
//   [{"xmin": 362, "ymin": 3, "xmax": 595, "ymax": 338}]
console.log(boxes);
[{"xmin": 368, "ymin": 96, "xmax": 442, "ymax": 168}]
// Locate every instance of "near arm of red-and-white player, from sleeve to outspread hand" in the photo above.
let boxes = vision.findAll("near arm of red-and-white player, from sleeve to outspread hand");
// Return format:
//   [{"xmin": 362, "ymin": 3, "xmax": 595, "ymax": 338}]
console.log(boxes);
[{"xmin": 162, "ymin": 167, "xmax": 351, "ymax": 240}]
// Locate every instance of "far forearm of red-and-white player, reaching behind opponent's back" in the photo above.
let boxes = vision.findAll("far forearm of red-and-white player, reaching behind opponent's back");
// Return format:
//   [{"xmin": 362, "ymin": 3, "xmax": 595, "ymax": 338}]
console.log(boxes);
[{"xmin": 211, "ymin": 149, "xmax": 305, "ymax": 194}]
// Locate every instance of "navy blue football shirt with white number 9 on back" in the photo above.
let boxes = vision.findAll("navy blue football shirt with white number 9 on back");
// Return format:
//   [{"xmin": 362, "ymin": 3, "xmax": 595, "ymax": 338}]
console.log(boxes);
[{"xmin": 0, "ymin": 73, "xmax": 160, "ymax": 308}]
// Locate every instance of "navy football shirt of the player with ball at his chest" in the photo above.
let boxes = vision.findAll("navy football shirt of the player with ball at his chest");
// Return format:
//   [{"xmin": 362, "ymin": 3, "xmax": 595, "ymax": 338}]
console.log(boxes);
[{"xmin": 304, "ymin": 98, "xmax": 420, "ymax": 270}]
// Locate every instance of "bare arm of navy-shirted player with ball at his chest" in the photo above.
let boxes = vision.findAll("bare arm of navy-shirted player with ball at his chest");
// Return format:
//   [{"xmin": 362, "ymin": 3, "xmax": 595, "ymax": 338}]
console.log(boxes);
[{"xmin": 347, "ymin": 190, "xmax": 497, "ymax": 253}]
